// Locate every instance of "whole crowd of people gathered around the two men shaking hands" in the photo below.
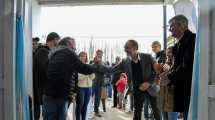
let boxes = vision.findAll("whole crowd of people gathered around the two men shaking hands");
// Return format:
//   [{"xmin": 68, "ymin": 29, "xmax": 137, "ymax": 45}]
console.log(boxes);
[{"xmin": 33, "ymin": 15, "xmax": 195, "ymax": 120}]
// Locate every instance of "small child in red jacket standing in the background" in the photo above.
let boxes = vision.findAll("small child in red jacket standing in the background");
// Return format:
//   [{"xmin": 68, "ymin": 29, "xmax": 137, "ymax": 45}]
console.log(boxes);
[{"xmin": 116, "ymin": 73, "xmax": 127, "ymax": 109}]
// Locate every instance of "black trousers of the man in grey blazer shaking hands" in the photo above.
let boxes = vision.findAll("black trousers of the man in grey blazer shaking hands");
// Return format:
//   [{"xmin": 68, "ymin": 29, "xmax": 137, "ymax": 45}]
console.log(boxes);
[{"xmin": 133, "ymin": 89, "xmax": 161, "ymax": 120}]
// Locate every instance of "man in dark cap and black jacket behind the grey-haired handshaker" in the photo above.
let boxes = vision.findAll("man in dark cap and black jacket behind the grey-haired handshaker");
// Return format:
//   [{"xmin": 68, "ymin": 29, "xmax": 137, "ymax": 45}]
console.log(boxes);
[{"xmin": 33, "ymin": 32, "xmax": 60, "ymax": 120}]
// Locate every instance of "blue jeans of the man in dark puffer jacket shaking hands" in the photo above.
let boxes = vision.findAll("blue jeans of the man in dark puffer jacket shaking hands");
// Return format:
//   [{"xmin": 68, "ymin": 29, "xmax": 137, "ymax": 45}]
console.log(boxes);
[{"xmin": 43, "ymin": 95, "xmax": 69, "ymax": 120}]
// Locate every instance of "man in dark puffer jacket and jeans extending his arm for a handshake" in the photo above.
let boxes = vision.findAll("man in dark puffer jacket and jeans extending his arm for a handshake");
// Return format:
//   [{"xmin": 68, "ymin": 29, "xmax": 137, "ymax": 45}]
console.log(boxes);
[{"xmin": 43, "ymin": 37, "xmax": 96, "ymax": 120}]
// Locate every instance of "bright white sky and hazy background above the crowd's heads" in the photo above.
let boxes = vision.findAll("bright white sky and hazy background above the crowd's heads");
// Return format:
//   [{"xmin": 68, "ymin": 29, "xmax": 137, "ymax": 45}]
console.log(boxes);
[{"xmin": 33, "ymin": 5, "xmax": 174, "ymax": 62}]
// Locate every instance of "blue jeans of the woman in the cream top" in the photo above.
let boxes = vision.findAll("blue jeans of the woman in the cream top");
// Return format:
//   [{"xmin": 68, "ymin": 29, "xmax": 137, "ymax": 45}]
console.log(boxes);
[{"xmin": 76, "ymin": 87, "xmax": 92, "ymax": 120}]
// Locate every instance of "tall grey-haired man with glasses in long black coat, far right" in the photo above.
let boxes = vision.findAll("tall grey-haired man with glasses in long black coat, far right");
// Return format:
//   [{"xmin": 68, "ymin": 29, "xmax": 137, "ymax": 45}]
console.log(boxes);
[{"xmin": 160, "ymin": 15, "xmax": 196, "ymax": 120}]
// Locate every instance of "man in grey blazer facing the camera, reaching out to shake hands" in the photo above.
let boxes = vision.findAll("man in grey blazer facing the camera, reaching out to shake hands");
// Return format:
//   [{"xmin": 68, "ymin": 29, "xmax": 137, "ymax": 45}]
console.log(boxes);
[{"xmin": 100, "ymin": 40, "xmax": 161, "ymax": 120}]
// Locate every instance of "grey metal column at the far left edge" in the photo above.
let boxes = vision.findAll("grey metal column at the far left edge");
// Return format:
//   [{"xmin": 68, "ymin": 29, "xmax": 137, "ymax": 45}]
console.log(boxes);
[{"xmin": 0, "ymin": 0, "xmax": 16, "ymax": 120}]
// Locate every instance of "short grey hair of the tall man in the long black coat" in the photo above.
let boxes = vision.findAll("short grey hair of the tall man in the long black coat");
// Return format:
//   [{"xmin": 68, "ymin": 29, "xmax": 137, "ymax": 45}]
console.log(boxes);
[{"xmin": 169, "ymin": 15, "xmax": 188, "ymax": 29}]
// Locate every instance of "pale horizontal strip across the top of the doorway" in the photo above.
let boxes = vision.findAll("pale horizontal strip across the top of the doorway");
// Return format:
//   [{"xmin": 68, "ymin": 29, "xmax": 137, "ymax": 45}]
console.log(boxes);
[{"xmin": 37, "ymin": 0, "xmax": 174, "ymax": 6}]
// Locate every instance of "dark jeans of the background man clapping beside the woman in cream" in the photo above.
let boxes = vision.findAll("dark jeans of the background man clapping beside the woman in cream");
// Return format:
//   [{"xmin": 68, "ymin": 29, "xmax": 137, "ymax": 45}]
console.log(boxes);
[{"xmin": 93, "ymin": 86, "xmax": 102, "ymax": 113}]
